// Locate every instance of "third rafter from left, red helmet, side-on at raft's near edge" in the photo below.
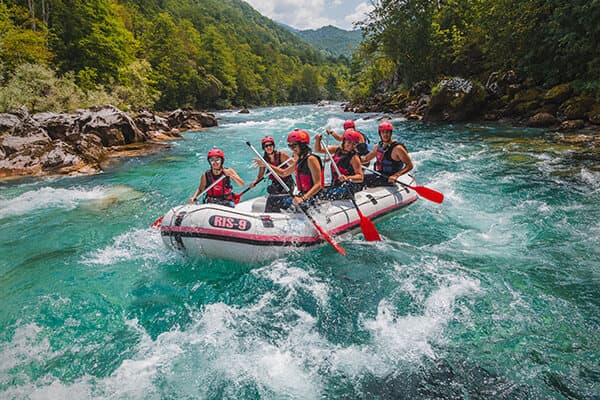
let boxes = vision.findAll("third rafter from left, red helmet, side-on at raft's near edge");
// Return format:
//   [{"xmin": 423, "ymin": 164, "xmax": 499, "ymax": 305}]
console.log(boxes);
[{"xmin": 258, "ymin": 129, "xmax": 324, "ymax": 212}]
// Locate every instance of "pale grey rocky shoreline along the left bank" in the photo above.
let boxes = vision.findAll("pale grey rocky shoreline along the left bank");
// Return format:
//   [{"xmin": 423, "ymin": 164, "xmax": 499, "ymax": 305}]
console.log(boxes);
[{"xmin": 0, "ymin": 105, "xmax": 217, "ymax": 180}]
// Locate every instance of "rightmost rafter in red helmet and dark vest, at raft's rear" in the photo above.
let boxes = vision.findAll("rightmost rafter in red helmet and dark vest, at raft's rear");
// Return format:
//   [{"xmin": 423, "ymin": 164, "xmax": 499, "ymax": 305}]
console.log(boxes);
[{"xmin": 361, "ymin": 121, "xmax": 413, "ymax": 186}]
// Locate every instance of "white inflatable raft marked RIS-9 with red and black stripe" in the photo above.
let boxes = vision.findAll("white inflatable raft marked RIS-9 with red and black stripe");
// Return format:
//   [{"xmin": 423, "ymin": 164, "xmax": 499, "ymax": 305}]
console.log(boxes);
[{"xmin": 160, "ymin": 175, "xmax": 417, "ymax": 263}]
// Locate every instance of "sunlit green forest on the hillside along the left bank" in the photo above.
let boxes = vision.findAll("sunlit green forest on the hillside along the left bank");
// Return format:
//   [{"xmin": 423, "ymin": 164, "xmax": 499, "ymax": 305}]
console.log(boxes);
[{"xmin": 0, "ymin": 0, "xmax": 349, "ymax": 111}]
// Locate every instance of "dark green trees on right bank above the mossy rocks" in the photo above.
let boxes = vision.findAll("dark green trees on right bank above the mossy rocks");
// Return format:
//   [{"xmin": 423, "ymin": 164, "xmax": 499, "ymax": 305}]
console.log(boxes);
[{"xmin": 353, "ymin": 0, "xmax": 600, "ymax": 98}]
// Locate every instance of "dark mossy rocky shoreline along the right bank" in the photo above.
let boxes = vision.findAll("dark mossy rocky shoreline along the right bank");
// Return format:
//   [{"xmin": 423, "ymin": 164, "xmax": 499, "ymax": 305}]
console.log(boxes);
[{"xmin": 344, "ymin": 71, "xmax": 600, "ymax": 132}]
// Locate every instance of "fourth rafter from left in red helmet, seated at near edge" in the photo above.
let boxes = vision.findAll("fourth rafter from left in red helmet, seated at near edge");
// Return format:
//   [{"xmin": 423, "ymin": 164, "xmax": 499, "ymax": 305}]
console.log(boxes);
[{"xmin": 315, "ymin": 129, "xmax": 363, "ymax": 200}]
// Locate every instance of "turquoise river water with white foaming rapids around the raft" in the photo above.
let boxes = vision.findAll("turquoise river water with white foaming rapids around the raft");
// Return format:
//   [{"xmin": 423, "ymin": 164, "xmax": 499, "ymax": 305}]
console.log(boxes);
[{"xmin": 0, "ymin": 106, "xmax": 600, "ymax": 399}]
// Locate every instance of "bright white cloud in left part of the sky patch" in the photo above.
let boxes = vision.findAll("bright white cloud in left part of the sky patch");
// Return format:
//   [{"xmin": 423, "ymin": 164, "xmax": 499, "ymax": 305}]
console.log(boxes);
[{"xmin": 246, "ymin": 0, "xmax": 336, "ymax": 29}]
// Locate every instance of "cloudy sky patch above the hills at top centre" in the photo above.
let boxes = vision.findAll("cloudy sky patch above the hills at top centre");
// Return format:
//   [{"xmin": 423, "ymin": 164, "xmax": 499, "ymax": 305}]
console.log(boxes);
[{"xmin": 241, "ymin": 0, "xmax": 372, "ymax": 30}]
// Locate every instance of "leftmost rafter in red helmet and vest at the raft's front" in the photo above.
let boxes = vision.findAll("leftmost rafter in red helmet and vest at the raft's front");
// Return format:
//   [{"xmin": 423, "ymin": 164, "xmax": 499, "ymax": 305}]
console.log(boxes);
[{"xmin": 189, "ymin": 149, "xmax": 244, "ymax": 207}]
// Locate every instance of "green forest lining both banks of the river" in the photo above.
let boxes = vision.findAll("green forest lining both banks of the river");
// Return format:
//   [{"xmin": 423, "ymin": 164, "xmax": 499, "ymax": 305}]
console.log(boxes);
[{"xmin": 0, "ymin": 0, "xmax": 600, "ymax": 111}]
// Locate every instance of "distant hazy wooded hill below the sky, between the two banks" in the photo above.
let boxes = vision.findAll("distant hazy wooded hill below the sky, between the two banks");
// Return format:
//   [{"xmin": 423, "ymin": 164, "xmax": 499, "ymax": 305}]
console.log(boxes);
[{"xmin": 295, "ymin": 25, "xmax": 362, "ymax": 58}]
